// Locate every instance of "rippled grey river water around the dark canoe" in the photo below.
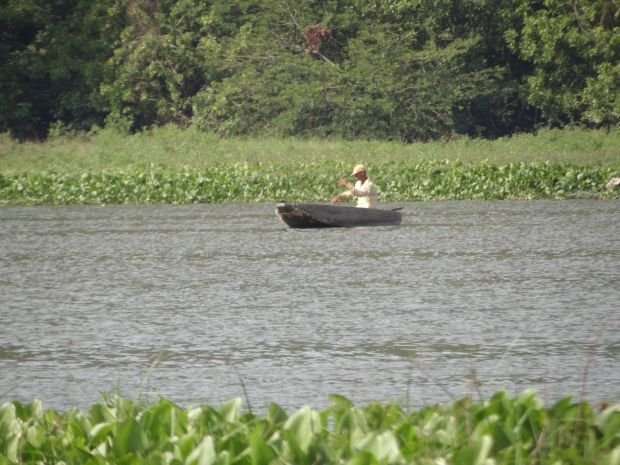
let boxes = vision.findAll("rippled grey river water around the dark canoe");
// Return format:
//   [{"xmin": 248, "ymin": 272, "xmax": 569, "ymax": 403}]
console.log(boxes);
[{"xmin": 0, "ymin": 200, "xmax": 620, "ymax": 412}]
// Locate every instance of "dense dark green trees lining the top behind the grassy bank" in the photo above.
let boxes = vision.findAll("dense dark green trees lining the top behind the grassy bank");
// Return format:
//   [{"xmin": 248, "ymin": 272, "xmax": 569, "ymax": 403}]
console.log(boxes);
[{"xmin": 0, "ymin": 0, "xmax": 620, "ymax": 141}]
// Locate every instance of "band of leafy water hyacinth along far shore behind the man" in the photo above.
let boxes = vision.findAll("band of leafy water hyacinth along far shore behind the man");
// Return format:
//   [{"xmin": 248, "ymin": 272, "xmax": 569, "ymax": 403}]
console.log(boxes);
[{"xmin": 0, "ymin": 161, "xmax": 620, "ymax": 205}]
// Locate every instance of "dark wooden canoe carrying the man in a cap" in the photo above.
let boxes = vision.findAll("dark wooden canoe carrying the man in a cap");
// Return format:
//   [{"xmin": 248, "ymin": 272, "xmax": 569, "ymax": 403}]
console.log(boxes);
[{"xmin": 276, "ymin": 202, "xmax": 402, "ymax": 228}]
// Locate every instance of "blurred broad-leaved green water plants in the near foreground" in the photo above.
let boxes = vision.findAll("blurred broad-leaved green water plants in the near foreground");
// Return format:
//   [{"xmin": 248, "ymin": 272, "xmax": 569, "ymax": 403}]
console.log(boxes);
[{"xmin": 0, "ymin": 390, "xmax": 620, "ymax": 465}]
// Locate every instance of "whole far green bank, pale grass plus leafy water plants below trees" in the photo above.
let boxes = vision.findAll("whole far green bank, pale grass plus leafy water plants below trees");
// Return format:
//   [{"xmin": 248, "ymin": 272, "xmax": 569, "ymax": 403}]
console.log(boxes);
[{"xmin": 0, "ymin": 126, "xmax": 620, "ymax": 205}]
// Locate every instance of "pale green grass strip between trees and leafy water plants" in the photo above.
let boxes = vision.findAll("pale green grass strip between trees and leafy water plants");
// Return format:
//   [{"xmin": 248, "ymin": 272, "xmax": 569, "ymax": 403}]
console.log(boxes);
[{"xmin": 0, "ymin": 126, "xmax": 620, "ymax": 175}]
